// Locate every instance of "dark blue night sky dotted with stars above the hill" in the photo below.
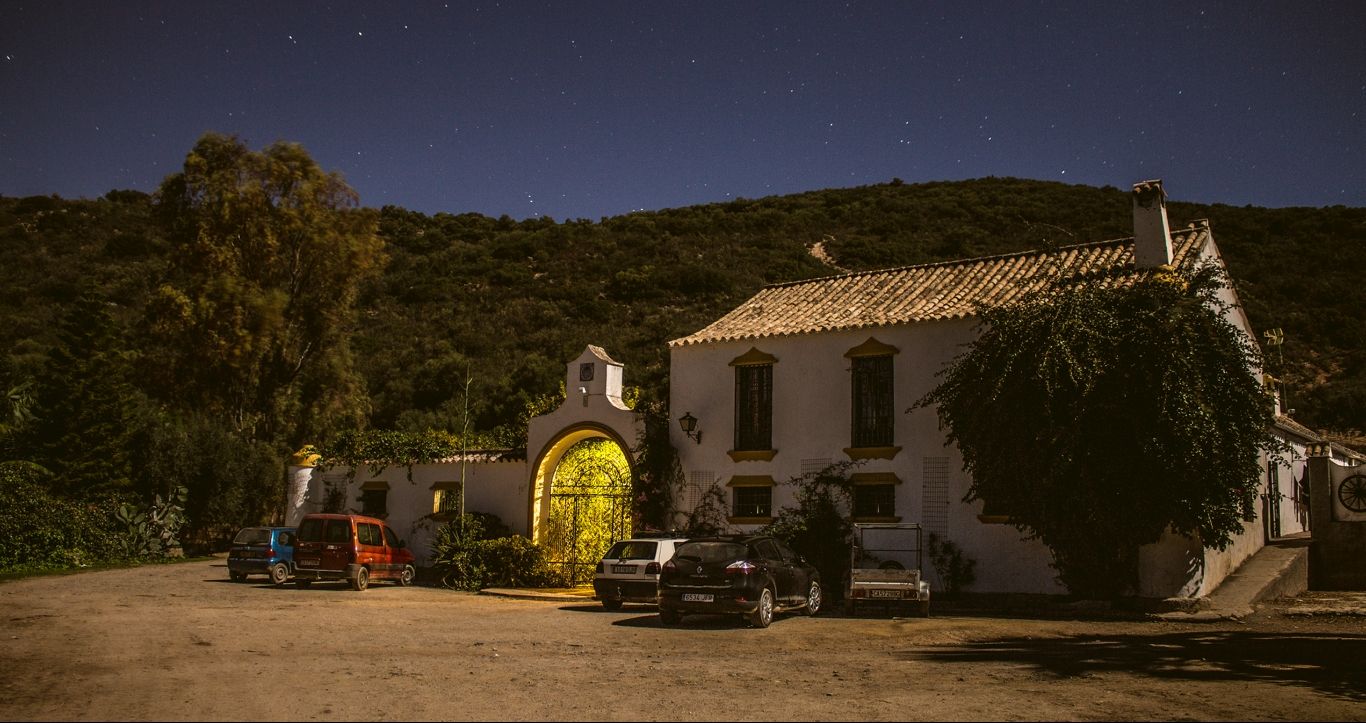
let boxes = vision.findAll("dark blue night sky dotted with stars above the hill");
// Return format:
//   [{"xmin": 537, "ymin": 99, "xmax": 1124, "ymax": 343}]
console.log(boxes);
[{"xmin": 0, "ymin": 0, "xmax": 1366, "ymax": 220}]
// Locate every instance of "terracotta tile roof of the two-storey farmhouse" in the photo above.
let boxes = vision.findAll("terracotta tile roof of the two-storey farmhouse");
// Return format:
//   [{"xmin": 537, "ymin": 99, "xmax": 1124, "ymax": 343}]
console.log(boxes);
[{"xmin": 669, "ymin": 223, "xmax": 1209, "ymax": 346}]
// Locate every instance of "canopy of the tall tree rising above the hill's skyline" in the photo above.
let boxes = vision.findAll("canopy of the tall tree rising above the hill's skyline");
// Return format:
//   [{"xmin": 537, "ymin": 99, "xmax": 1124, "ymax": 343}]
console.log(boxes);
[{"xmin": 152, "ymin": 133, "xmax": 385, "ymax": 443}]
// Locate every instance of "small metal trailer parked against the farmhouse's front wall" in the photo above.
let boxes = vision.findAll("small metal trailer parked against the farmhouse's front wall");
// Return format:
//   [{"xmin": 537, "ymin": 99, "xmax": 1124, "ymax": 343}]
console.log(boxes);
[{"xmin": 844, "ymin": 522, "xmax": 930, "ymax": 618}]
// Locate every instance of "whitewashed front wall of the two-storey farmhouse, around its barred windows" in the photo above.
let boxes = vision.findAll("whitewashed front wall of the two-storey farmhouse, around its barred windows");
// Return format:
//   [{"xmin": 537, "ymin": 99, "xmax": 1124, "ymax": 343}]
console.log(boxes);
[{"xmin": 669, "ymin": 320, "xmax": 1064, "ymax": 593}]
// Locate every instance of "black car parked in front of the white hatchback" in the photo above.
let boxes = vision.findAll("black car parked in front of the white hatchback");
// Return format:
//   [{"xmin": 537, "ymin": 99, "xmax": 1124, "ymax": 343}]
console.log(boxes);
[{"xmin": 660, "ymin": 534, "xmax": 821, "ymax": 627}]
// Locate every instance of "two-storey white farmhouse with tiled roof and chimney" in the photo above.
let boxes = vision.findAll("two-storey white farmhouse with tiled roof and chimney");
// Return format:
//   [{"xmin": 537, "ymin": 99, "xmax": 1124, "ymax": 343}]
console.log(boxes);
[{"xmin": 669, "ymin": 182, "xmax": 1313, "ymax": 599}]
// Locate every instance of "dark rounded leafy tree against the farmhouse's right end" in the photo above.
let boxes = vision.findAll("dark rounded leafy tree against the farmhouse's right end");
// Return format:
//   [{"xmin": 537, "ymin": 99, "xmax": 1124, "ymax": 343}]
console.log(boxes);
[{"xmin": 917, "ymin": 264, "xmax": 1277, "ymax": 597}]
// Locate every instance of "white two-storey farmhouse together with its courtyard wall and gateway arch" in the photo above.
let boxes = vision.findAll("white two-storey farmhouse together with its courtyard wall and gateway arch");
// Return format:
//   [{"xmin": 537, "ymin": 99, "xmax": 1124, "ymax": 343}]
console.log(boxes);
[{"xmin": 285, "ymin": 182, "xmax": 1322, "ymax": 599}]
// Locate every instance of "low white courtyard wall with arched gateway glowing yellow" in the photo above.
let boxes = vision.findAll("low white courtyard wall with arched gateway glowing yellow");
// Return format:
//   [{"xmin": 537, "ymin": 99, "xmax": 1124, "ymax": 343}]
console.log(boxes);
[{"xmin": 285, "ymin": 346, "xmax": 643, "ymax": 578}]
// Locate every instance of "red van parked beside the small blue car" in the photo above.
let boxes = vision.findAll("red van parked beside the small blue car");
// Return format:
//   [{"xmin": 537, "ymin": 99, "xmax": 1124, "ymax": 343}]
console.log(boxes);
[{"xmin": 294, "ymin": 514, "xmax": 417, "ymax": 590}]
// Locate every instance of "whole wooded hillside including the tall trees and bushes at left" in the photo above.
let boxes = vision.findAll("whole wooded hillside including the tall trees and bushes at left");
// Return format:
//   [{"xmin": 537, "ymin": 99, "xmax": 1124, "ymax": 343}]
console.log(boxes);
[{"xmin": 0, "ymin": 137, "xmax": 1366, "ymax": 568}]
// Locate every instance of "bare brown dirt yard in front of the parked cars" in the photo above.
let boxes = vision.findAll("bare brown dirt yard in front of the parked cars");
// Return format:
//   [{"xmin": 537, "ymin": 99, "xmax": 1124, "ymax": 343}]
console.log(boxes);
[{"xmin": 0, "ymin": 559, "xmax": 1366, "ymax": 720}]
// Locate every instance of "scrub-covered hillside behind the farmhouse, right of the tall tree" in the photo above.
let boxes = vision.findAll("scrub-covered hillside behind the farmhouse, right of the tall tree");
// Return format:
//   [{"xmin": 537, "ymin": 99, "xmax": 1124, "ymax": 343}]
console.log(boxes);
[{"xmin": 346, "ymin": 179, "xmax": 1366, "ymax": 443}]
